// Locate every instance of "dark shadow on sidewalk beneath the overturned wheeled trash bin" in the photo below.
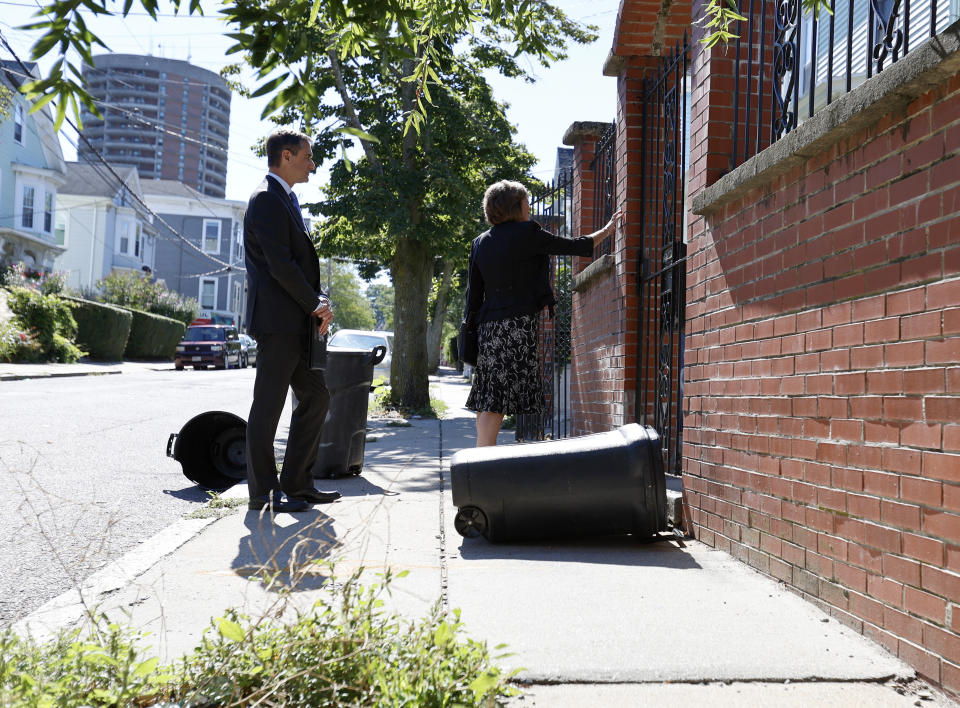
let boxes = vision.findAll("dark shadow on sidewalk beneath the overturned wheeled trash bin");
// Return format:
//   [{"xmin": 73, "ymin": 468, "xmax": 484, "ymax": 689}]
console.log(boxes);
[{"xmin": 459, "ymin": 534, "xmax": 702, "ymax": 570}]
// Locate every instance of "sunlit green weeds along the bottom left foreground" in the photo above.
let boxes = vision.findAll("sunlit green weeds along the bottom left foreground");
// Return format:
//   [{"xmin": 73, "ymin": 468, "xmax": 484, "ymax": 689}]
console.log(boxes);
[{"xmin": 0, "ymin": 571, "xmax": 517, "ymax": 708}]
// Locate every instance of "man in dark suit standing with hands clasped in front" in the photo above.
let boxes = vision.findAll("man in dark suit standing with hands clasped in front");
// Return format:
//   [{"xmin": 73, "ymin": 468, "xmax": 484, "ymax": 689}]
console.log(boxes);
[{"xmin": 243, "ymin": 128, "xmax": 340, "ymax": 512}]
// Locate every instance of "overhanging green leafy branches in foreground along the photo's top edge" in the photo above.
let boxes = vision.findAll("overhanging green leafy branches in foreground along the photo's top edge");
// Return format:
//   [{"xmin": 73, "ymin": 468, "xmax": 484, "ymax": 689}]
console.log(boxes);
[{"xmin": 24, "ymin": 0, "xmax": 592, "ymax": 129}]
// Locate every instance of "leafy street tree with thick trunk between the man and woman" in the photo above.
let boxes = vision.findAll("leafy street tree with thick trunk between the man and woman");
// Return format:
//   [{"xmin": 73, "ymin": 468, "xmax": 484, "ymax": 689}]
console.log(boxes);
[{"xmin": 314, "ymin": 50, "xmax": 534, "ymax": 408}]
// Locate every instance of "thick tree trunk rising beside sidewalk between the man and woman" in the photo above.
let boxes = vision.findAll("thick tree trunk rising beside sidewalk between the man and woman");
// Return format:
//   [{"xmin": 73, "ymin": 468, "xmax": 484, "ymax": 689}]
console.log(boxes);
[{"xmin": 390, "ymin": 236, "xmax": 433, "ymax": 410}]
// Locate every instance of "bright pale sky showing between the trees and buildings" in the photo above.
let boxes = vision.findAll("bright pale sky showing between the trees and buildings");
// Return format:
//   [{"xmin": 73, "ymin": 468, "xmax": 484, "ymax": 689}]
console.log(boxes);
[{"xmin": 0, "ymin": 0, "xmax": 619, "ymax": 208}]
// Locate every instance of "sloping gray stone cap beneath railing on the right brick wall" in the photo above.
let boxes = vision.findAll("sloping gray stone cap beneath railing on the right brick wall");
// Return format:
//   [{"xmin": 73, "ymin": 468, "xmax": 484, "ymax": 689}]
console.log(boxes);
[{"xmin": 690, "ymin": 20, "xmax": 960, "ymax": 215}]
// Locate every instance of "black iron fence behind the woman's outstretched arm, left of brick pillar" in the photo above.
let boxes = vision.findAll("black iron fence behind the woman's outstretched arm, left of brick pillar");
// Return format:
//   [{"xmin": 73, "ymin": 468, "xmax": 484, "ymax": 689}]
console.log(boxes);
[{"xmin": 516, "ymin": 169, "xmax": 573, "ymax": 441}]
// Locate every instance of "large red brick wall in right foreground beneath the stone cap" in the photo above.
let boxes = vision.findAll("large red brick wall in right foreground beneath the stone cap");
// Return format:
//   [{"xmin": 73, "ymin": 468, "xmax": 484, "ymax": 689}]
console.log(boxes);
[{"xmin": 684, "ymin": 58, "xmax": 960, "ymax": 691}]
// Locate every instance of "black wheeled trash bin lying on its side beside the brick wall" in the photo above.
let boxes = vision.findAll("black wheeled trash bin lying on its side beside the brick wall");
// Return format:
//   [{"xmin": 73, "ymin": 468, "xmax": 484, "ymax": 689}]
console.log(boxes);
[{"xmin": 450, "ymin": 423, "xmax": 667, "ymax": 542}]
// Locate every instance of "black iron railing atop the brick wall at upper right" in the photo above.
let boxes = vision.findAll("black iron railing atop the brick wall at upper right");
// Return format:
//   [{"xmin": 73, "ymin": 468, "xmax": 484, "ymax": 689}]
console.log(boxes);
[{"xmin": 729, "ymin": 0, "xmax": 960, "ymax": 169}]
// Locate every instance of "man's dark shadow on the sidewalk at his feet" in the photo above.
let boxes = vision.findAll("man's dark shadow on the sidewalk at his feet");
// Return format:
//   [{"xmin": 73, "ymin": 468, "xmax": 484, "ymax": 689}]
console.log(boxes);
[{"xmin": 231, "ymin": 509, "xmax": 339, "ymax": 592}]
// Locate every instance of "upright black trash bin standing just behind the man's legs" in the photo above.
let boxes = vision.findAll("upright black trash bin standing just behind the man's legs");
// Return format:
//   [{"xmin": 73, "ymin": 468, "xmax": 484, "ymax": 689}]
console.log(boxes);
[{"xmin": 313, "ymin": 346, "xmax": 387, "ymax": 478}]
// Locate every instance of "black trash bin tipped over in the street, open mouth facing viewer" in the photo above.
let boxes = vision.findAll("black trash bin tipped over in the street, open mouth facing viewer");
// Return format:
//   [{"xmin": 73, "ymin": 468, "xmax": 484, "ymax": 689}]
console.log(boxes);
[{"xmin": 167, "ymin": 411, "xmax": 247, "ymax": 491}]
